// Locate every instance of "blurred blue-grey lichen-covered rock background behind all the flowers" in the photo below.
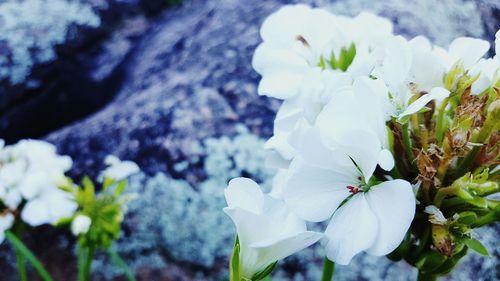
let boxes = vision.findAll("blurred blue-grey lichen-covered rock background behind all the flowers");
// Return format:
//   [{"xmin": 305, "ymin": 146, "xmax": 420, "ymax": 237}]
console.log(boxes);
[{"xmin": 0, "ymin": 0, "xmax": 500, "ymax": 281}]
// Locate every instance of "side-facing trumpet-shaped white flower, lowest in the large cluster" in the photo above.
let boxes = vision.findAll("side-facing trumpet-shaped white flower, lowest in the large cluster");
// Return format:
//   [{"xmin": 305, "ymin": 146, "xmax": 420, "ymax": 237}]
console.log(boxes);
[{"xmin": 224, "ymin": 178, "xmax": 322, "ymax": 280}]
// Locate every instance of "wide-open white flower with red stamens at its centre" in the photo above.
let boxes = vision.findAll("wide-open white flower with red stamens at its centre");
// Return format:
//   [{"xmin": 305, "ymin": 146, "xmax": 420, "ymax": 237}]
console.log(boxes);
[{"xmin": 283, "ymin": 128, "xmax": 415, "ymax": 264}]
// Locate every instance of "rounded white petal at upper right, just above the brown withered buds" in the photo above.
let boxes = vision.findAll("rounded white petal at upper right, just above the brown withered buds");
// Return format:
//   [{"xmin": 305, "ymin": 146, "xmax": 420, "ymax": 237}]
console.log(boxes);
[{"xmin": 448, "ymin": 37, "xmax": 490, "ymax": 69}]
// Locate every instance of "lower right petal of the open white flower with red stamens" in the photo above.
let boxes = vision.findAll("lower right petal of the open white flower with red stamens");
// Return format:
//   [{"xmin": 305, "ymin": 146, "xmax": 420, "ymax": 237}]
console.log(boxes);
[{"xmin": 366, "ymin": 180, "xmax": 415, "ymax": 256}]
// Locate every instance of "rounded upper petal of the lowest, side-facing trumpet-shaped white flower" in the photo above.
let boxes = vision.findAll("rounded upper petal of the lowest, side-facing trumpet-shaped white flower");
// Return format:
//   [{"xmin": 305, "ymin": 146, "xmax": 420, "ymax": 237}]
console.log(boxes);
[{"xmin": 224, "ymin": 178, "xmax": 264, "ymax": 214}]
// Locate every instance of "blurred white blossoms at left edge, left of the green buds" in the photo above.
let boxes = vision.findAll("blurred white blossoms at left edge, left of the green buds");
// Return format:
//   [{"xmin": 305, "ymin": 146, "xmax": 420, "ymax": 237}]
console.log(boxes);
[{"xmin": 0, "ymin": 140, "xmax": 77, "ymax": 238}]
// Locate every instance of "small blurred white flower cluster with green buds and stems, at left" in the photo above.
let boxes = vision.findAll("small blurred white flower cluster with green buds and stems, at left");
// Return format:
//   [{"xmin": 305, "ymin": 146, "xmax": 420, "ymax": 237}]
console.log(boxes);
[{"xmin": 0, "ymin": 140, "xmax": 139, "ymax": 281}]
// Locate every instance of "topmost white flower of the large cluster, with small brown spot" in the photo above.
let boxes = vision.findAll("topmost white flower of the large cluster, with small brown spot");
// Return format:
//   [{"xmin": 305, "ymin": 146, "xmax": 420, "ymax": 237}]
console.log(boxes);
[{"xmin": 252, "ymin": 5, "xmax": 364, "ymax": 100}]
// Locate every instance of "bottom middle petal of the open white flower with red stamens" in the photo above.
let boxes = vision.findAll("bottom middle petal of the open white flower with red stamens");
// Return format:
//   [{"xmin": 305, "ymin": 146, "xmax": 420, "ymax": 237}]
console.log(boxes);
[{"xmin": 325, "ymin": 193, "xmax": 378, "ymax": 265}]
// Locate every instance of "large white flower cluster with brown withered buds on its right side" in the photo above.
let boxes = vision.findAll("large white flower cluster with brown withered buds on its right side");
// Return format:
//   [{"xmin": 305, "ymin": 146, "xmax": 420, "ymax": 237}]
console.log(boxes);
[{"xmin": 225, "ymin": 5, "xmax": 500, "ymax": 281}]
